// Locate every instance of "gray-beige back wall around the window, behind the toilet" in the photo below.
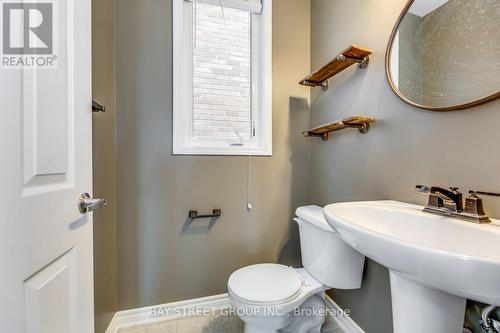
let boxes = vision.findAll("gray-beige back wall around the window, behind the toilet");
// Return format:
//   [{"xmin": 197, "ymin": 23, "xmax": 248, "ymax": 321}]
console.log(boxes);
[{"xmin": 116, "ymin": 0, "xmax": 310, "ymax": 309}]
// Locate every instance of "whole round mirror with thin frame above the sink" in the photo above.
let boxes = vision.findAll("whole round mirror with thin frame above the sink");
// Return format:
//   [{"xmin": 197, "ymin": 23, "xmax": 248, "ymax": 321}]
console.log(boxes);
[{"xmin": 386, "ymin": 0, "xmax": 500, "ymax": 111}]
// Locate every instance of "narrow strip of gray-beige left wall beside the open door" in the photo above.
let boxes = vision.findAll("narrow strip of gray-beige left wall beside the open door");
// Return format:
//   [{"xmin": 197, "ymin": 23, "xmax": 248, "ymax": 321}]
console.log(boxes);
[{"xmin": 92, "ymin": 0, "xmax": 117, "ymax": 333}]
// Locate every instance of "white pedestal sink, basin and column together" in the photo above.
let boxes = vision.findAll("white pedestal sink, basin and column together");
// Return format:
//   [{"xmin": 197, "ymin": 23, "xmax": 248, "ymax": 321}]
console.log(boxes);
[{"xmin": 324, "ymin": 201, "xmax": 500, "ymax": 333}]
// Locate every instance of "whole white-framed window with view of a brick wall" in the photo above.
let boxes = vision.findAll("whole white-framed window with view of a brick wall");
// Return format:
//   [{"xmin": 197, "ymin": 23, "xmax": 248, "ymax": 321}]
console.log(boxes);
[{"xmin": 173, "ymin": 0, "xmax": 272, "ymax": 155}]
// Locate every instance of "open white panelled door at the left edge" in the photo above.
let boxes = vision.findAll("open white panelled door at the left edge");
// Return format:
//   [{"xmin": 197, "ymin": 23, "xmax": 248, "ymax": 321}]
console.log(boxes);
[{"xmin": 0, "ymin": 0, "xmax": 94, "ymax": 333}]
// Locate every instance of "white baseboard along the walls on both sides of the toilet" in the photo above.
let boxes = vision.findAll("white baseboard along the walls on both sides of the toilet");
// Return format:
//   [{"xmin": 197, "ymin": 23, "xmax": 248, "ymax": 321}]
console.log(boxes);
[{"xmin": 106, "ymin": 294, "xmax": 365, "ymax": 333}]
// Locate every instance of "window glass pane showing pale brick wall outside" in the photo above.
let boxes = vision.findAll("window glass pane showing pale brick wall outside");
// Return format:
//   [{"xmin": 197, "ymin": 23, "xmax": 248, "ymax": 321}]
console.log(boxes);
[{"xmin": 192, "ymin": 3, "xmax": 252, "ymax": 141}]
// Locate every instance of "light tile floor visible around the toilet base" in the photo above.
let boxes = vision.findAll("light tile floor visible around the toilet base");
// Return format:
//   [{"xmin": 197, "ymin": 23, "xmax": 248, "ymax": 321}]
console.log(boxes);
[{"xmin": 118, "ymin": 308, "xmax": 342, "ymax": 333}]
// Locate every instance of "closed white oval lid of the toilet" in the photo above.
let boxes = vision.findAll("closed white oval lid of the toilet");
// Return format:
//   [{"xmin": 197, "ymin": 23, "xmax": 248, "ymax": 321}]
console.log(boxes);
[{"xmin": 228, "ymin": 264, "xmax": 302, "ymax": 303}]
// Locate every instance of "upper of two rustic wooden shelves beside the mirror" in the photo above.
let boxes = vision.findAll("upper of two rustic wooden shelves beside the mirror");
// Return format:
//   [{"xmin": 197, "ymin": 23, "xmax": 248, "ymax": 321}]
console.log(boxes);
[{"xmin": 299, "ymin": 45, "xmax": 372, "ymax": 90}]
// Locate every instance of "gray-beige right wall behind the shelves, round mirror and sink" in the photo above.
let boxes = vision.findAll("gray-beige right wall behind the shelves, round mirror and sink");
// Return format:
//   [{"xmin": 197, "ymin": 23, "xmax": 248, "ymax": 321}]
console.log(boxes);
[{"xmin": 311, "ymin": 0, "xmax": 500, "ymax": 333}]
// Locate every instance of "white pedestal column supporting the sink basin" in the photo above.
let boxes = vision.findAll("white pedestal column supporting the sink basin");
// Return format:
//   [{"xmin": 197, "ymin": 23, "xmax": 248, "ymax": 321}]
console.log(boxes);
[{"xmin": 390, "ymin": 271, "xmax": 467, "ymax": 333}]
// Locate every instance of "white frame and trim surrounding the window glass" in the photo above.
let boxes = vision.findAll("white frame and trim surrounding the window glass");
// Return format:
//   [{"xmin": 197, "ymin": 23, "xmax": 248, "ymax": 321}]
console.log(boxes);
[{"xmin": 172, "ymin": 0, "xmax": 272, "ymax": 156}]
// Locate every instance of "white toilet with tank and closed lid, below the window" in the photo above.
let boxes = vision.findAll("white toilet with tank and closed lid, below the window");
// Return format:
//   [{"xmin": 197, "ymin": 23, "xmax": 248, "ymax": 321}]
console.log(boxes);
[{"xmin": 228, "ymin": 206, "xmax": 365, "ymax": 333}]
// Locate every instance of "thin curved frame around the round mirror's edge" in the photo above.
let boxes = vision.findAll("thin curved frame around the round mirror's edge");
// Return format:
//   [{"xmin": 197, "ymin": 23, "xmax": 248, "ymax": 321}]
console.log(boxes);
[{"xmin": 385, "ymin": 0, "xmax": 500, "ymax": 112}]
